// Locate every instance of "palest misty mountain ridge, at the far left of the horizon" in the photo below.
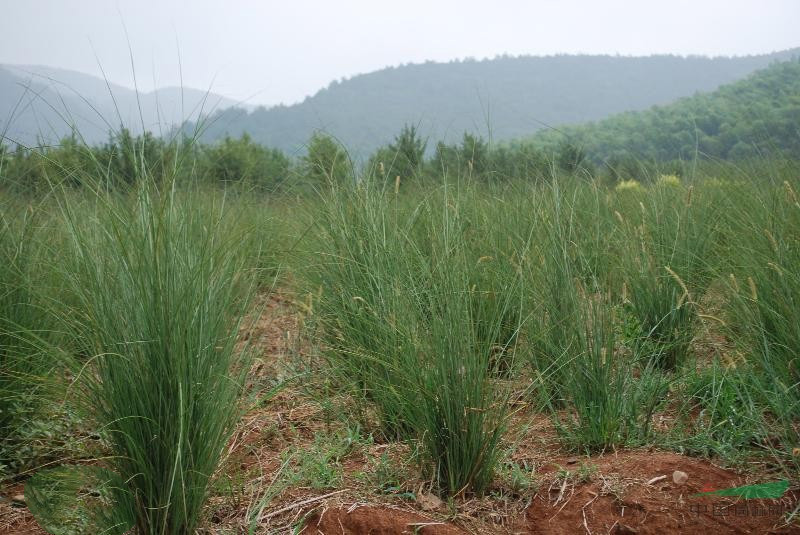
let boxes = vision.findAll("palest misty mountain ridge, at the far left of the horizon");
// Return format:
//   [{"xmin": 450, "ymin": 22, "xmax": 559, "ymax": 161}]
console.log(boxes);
[{"xmin": 0, "ymin": 65, "xmax": 245, "ymax": 145}]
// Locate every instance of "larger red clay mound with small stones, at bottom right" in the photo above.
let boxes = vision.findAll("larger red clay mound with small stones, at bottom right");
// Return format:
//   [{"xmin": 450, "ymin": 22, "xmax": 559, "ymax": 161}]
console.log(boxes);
[{"xmin": 513, "ymin": 452, "xmax": 800, "ymax": 535}]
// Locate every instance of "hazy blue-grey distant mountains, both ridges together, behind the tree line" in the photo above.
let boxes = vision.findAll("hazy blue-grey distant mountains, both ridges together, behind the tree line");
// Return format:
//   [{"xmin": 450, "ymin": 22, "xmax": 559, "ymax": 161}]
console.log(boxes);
[{"xmin": 0, "ymin": 49, "xmax": 800, "ymax": 156}]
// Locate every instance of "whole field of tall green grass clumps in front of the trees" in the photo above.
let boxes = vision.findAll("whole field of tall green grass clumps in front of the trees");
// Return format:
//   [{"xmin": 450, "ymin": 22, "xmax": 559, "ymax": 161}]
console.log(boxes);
[{"xmin": 6, "ymin": 137, "xmax": 800, "ymax": 510}]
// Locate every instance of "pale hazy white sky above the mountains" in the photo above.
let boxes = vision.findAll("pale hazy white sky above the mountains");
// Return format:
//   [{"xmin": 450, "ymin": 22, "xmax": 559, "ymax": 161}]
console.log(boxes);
[{"xmin": 0, "ymin": 0, "xmax": 800, "ymax": 104}]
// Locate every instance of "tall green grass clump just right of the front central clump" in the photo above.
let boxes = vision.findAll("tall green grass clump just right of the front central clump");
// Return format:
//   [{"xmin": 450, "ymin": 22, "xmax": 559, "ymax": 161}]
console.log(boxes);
[{"xmin": 527, "ymin": 183, "xmax": 669, "ymax": 451}]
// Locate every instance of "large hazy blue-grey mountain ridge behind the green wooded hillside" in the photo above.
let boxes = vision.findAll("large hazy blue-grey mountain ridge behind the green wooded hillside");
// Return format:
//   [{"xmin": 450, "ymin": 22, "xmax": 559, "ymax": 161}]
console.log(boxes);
[{"xmin": 190, "ymin": 49, "xmax": 800, "ymax": 156}]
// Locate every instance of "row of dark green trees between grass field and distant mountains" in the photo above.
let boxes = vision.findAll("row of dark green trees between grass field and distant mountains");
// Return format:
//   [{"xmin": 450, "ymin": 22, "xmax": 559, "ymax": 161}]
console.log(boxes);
[{"xmin": 0, "ymin": 120, "xmax": 792, "ymax": 194}]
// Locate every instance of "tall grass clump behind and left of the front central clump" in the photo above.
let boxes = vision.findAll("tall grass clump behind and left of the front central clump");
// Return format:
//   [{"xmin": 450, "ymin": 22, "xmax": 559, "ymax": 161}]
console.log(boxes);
[{"xmin": 304, "ymin": 180, "xmax": 417, "ymax": 438}]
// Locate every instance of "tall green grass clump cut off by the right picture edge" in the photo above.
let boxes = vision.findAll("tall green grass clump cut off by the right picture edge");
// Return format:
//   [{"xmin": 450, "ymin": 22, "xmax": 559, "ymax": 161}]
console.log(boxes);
[{"xmin": 729, "ymin": 180, "xmax": 800, "ymax": 470}]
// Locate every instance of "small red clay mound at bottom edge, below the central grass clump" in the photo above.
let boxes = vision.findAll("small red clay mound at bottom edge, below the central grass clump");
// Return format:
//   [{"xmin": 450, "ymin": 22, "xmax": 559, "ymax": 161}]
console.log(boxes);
[{"xmin": 300, "ymin": 506, "xmax": 467, "ymax": 535}]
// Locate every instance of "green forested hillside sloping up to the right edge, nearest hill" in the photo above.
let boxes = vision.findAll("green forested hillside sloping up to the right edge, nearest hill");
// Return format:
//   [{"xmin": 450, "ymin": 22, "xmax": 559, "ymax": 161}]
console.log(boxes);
[{"xmin": 517, "ymin": 56, "xmax": 800, "ymax": 162}]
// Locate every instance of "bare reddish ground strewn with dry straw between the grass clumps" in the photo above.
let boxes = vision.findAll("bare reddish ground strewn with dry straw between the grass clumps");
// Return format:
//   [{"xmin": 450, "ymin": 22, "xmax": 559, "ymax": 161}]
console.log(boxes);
[{"xmin": 0, "ymin": 292, "xmax": 800, "ymax": 535}]
